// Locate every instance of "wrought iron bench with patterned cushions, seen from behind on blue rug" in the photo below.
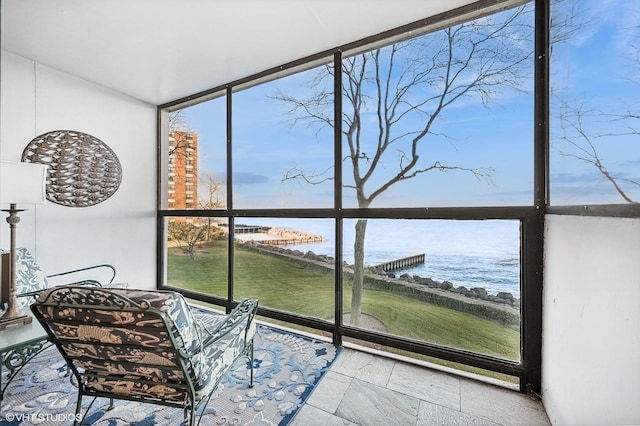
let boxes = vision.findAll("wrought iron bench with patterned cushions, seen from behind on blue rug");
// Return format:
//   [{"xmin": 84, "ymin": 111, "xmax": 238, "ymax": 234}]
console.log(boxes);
[{"xmin": 31, "ymin": 286, "xmax": 258, "ymax": 425}]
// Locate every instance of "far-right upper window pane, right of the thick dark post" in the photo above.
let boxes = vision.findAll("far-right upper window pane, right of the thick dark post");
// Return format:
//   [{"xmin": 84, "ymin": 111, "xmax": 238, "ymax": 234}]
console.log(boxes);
[{"xmin": 550, "ymin": 0, "xmax": 640, "ymax": 205}]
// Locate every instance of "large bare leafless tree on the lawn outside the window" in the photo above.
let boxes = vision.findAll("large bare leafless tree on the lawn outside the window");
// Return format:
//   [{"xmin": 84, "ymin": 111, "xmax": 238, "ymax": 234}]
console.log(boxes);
[{"xmin": 275, "ymin": 5, "xmax": 533, "ymax": 326}]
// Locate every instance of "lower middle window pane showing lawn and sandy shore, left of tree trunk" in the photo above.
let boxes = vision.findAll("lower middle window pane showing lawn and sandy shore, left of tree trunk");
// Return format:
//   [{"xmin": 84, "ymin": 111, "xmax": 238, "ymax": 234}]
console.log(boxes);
[{"xmin": 234, "ymin": 218, "xmax": 335, "ymax": 321}]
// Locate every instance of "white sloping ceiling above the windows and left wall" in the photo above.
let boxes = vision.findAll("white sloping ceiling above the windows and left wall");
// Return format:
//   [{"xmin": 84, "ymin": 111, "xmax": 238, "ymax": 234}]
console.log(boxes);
[{"xmin": 1, "ymin": 0, "xmax": 474, "ymax": 105}]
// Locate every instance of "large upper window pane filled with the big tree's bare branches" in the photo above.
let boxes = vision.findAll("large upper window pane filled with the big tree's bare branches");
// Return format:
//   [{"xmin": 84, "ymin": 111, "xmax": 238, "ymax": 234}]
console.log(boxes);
[{"xmin": 342, "ymin": 4, "xmax": 534, "ymax": 208}]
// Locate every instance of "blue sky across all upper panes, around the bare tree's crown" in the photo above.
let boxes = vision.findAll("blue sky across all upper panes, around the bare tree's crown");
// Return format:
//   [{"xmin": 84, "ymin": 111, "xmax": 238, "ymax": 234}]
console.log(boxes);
[{"xmin": 176, "ymin": 0, "xmax": 640, "ymax": 208}]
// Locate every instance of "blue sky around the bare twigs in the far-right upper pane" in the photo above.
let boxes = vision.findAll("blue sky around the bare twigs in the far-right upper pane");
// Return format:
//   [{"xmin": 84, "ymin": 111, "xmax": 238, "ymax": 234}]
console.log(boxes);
[{"xmin": 551, "ymin": 0, "xmax": 640, "ymax": 204}]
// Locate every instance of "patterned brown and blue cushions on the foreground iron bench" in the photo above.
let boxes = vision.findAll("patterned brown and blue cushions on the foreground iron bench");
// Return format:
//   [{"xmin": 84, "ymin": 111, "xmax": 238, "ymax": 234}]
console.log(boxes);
[{"xmin": 30, "ymin": 287, "xmax": 255, "ymax": 402}]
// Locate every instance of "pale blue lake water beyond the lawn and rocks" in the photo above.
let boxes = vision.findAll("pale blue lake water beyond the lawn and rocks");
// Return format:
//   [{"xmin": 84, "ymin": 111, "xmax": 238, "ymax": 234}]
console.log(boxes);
[{"xmin": 236, "ymin": 218, "xmax": 520, "ymax": 298}]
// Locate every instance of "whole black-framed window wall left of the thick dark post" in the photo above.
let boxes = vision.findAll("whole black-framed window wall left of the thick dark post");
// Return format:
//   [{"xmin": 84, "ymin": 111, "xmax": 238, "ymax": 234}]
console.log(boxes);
[{"xmin": 158, "ymin": 2, "xmax": 541, "ymax": 388}]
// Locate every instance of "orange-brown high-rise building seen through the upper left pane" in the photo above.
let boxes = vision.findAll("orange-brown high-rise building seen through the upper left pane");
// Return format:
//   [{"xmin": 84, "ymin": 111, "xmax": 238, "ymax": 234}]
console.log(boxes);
[{"xmin": 168, "ymin": 130, "xmax": 198, "ymax": 210}]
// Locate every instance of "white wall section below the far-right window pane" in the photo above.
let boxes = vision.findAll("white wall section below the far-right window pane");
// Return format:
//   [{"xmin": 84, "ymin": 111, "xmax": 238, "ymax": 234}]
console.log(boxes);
[{"xmin": 542, "ymin": 215, "xmax": 640, "ymax": 425}]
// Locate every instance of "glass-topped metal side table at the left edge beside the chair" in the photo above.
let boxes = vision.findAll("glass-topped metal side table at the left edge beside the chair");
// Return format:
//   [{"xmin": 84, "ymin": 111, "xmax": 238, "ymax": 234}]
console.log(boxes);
[{"xmin": 0, "ymin": 309, "xmax": 51, "ymax": 405}]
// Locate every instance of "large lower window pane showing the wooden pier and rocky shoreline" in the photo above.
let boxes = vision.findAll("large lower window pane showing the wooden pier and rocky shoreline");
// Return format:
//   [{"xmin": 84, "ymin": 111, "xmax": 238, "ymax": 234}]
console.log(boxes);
[{"xmin": 343, "ymin": 219, "xmax": 520, "ymax": 360}]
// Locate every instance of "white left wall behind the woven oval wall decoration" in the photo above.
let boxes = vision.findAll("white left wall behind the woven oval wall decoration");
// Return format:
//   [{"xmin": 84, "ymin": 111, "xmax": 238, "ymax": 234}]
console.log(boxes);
[{"xmin": 0, "ymin": 51, "xmax": 156, "ymax": 288}]
